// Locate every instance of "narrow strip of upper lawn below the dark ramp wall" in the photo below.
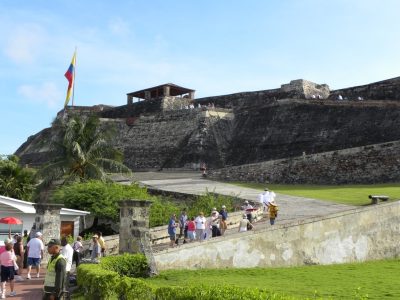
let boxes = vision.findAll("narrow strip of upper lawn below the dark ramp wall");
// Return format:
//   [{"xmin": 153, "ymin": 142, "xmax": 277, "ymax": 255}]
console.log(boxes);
[{"xmin": 227, "ymin": 182, "xmax": 400, "ymax": 205}]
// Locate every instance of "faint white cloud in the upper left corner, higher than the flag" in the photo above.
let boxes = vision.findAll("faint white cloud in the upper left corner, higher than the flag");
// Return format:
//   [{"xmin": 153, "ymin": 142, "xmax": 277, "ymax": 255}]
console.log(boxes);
[{"xmin": 4, "ymin": 24, "xmax": 46, "ymax": 64}]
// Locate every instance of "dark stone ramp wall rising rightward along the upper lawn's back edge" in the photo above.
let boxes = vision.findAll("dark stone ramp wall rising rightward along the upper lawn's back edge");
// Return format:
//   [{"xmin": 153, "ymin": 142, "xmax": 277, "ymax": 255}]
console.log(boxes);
[{"xmin": 208, "ymin": 141, "xmax": 400, "ymax": 184}]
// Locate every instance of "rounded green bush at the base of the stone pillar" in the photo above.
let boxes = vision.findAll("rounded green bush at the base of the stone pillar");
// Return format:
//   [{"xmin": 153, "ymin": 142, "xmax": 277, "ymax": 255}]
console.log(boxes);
[{"xmin": 100, "ymin": 253, "xmax": 149, "ymax": 277}]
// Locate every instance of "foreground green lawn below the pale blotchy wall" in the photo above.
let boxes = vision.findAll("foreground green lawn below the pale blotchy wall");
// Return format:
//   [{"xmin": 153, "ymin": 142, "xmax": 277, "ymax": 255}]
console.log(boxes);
[{"xmin": 146, "ymin": 259, "xmax": 400, "ymax": 299}]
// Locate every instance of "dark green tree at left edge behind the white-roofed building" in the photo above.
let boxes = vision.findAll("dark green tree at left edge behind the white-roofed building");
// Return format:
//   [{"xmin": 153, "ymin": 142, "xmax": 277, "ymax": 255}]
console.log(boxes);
[{"xmin": 0, "ymin": 155, "xmax": 36, "ymax": 201}]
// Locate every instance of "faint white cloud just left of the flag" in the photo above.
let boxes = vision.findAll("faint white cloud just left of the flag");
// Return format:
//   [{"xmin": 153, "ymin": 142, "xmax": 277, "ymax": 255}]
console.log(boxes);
[{"xmin": 18, "ymin": 82, "xmax": 63, "ymax": 108}]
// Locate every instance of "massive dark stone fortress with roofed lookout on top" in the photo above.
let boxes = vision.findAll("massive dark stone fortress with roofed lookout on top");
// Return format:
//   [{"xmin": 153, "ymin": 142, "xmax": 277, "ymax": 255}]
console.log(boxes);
[{"xmin": 15, "ymin": 77, "xmax": 400, "ymax": 184}]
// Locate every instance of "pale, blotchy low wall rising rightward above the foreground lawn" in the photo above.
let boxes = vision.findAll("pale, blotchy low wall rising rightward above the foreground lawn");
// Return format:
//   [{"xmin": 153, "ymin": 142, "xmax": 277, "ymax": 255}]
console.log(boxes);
[{"xmin": 154, "ymin": 202, "xmax": 400, "ymax": 270}]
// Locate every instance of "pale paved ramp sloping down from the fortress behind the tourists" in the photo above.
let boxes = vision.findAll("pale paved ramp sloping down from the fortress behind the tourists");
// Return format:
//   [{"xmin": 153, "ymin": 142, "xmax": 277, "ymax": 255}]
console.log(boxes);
[{"xmin": 134, "ymin": 172, "xmax": 355, "ymax": 223}]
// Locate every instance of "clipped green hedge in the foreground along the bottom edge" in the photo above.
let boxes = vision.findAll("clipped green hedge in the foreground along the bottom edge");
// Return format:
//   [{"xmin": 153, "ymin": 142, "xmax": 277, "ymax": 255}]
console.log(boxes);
[{"xmin": 77, "ymin": 262, "xmax": 294, "ymax": 300}]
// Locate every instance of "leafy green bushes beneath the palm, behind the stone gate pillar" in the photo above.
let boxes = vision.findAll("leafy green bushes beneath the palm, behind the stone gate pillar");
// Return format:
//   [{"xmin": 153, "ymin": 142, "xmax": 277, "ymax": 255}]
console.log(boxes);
[{"xmin": 52, "ymin": 180, "xmax": 152, "ymax": 227}]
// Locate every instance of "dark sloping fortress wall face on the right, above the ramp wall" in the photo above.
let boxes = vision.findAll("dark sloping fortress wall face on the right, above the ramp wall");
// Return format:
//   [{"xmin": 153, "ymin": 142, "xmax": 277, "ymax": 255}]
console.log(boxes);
[{"xmin": 226, "ymin": 99, "xmax": 400, "ymax": 165}]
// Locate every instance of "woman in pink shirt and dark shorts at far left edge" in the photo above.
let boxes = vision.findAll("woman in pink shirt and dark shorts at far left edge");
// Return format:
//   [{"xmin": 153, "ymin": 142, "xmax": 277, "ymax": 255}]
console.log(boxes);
[{"xmin": 0, "ymin": 239, "xmax": 17, "ymax": 299}]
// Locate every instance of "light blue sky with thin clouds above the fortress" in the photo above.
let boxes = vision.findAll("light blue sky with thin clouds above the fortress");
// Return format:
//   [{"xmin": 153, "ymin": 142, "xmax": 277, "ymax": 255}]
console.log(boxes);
[{"xmin": 0, "ymin": 0, "xmax": 400, "ymax": 154}]
